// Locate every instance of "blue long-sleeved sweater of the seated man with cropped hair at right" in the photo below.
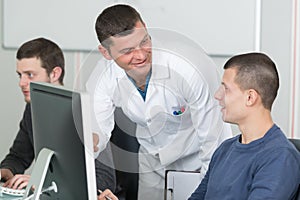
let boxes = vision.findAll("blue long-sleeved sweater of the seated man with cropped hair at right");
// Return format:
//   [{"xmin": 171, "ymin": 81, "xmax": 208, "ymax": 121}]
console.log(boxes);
[{"xmin": 189, "ymin": 125, "xmax": 300, "ymax": 200}]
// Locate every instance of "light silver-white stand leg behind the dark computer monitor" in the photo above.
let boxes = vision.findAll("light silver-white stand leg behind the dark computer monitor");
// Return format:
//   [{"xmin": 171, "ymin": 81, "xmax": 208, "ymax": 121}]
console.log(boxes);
[{"xmin": 23, "ymin": 148, "xmax": 54, "ymax": 200}]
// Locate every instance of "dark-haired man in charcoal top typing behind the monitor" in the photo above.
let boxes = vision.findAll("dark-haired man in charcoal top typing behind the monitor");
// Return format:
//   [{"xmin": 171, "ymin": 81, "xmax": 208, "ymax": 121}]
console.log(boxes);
[{"xmin": 0, "ymin": 38, "xmax": 115, "ymax": 191}]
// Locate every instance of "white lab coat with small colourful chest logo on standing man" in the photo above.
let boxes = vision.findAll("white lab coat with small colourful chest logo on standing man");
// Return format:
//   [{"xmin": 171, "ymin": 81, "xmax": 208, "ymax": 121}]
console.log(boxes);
[{"xmin": 87, "ymin": 43, "xmax": 231, "ymax": 199}]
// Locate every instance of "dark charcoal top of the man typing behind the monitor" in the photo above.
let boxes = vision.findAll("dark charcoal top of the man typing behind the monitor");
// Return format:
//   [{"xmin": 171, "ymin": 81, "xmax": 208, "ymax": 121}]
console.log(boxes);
[{"xmin": 0, "ymin": 104, "xmax": 116, "ymax": 191}]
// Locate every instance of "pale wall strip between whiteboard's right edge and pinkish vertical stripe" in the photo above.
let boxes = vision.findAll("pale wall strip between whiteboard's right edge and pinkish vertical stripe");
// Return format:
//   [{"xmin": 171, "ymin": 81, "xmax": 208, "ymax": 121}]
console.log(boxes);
[{"xmin": 261, "ymin": 0, "xmax": 300, "ymax": 137}]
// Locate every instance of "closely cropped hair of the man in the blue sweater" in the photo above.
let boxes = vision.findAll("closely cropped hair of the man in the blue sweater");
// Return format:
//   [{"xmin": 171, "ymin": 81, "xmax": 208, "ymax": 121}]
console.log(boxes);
[{"xmin": 224, "ymin": 53, "xmax": 279, "ymax": 111}]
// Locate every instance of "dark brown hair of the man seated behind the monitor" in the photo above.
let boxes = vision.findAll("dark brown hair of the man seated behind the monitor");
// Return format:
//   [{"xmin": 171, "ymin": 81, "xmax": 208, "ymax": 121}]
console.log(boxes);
[{"xmin": 16, "ymin": 38, "xmax": 65, "ymax": 85}]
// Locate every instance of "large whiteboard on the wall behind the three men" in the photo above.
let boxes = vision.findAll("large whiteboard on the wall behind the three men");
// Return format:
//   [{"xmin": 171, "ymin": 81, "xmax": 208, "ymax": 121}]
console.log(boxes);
[{"xmin": 2, "ymin": 0, "xmax": 257, "ymax": 55}]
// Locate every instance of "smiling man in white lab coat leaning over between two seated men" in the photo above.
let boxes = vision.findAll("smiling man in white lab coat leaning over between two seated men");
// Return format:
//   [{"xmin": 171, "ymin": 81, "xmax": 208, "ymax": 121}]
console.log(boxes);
[{"xmin": 87, "ymin": 5, "xmax": 231, "ymax": 200}]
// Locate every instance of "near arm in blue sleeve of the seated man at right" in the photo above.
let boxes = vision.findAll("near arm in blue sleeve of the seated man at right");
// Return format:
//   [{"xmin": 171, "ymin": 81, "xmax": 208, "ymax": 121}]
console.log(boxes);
[{"xmin": 248, "ymin": 148, "xmax": 300, "ymax": 200}]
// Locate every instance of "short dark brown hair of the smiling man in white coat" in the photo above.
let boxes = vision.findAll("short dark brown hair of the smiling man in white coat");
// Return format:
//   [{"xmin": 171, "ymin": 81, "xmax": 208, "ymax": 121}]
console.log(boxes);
[{"xmin": 95, "ymin": 4, "xmax": 144, "ymax": 48}]
